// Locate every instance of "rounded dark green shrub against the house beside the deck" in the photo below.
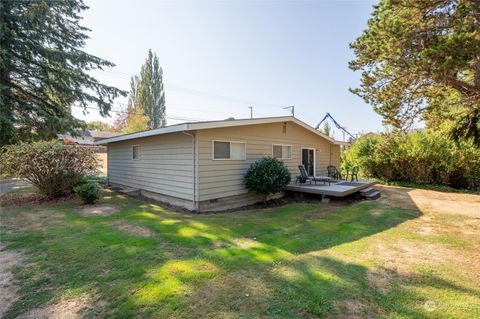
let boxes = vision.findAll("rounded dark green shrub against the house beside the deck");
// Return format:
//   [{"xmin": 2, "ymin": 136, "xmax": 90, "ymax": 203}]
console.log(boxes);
[{"xmin": 245, "ymin": 157, "xmax": 291, "ymax": 201}]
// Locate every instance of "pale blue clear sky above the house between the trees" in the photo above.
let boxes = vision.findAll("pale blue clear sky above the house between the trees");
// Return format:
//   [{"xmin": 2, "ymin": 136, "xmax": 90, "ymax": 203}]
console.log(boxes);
[{"xmin": 74, "ymin": 0, "xmax": 382, "ymax": 138}]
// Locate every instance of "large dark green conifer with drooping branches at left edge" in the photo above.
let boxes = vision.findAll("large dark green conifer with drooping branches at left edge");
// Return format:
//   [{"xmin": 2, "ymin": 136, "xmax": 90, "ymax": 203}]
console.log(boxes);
[{"xmin": 0, "ymin": 0, "xmax": 125, "ymax": 145}]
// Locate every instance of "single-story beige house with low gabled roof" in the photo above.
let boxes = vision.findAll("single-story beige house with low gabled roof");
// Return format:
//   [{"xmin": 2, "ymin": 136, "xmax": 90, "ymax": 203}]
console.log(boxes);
[{"xmin": 95, "ymin": 116, "xmax": 342, "ymax": 211}]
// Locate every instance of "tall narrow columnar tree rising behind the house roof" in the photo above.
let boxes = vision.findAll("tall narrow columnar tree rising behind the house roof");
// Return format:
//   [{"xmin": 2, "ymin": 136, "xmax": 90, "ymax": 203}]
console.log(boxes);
[{"xmin": 128, "ymin": 50, "xmax": 166, "ymax": 129}]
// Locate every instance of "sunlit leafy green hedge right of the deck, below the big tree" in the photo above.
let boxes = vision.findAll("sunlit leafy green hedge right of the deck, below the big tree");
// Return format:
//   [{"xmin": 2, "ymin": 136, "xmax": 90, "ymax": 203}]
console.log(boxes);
[{"xmin": 342, "ymin": 131, "xmax": 480, "ymax": 189}]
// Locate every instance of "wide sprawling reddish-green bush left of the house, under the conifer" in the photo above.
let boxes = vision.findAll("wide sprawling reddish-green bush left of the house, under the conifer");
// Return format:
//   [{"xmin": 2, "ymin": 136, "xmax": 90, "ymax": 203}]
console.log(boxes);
[{"xmin": 1, "ymin": 141, "xmax": 98, "ymax": 198}]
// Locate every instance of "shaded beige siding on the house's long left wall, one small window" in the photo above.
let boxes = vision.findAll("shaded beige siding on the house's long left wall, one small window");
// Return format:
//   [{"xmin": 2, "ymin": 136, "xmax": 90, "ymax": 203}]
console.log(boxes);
[{"xmin": 108, "ymin": 133, "xmax": 194, "ymax": 201}]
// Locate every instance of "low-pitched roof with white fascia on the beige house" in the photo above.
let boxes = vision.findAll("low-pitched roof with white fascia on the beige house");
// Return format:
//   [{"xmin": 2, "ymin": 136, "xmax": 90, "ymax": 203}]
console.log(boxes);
[{"xmin": 95, "ymin": 116, "xmax": 344, "ymax": 145}]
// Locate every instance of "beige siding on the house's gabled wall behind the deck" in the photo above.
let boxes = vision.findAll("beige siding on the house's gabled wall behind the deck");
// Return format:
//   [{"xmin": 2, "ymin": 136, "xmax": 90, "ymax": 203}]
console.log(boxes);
[{"xmin": 196, "ymin": 122, "xmax": 340, "ymax": 201}]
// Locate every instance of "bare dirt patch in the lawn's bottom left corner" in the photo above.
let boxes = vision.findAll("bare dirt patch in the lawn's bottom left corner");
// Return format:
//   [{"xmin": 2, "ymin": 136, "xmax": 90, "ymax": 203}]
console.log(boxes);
[{"xmin": 0, "ymin": 244, "xmax": 24, "ymax": 318}]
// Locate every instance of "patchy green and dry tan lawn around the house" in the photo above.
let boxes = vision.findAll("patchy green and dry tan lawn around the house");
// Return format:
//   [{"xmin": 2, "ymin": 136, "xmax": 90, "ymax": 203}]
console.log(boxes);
[{"xmin": 1, "ymin": 189, "xmax": 480, "ymax": 318}]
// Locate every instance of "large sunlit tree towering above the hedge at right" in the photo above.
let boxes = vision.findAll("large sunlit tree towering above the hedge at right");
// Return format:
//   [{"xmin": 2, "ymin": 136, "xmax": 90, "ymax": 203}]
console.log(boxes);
[{"xmin": 350, "ymin": 0, "xmax": 480, "ymax": 141}]
